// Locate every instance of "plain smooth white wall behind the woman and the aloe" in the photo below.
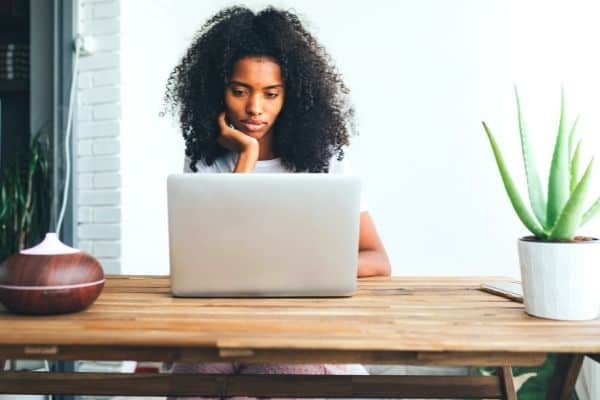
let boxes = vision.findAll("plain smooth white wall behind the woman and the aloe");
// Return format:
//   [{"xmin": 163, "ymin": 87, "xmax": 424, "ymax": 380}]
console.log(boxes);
[{"xmin": 121, "ymin": 0, "xmax": 600, "ymax": 276}]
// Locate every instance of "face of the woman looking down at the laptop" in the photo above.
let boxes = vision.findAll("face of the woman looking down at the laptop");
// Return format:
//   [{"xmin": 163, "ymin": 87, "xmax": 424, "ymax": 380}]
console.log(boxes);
[{"xmin": 225, "ymin": 57, "xmax": 285, "ymax": 141}]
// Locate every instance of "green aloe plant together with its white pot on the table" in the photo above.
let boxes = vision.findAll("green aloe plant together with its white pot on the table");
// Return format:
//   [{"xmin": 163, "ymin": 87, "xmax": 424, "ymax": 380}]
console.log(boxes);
[{"xmin": 483, "ymin": 88, "xmax": 600, "ymax": 320}]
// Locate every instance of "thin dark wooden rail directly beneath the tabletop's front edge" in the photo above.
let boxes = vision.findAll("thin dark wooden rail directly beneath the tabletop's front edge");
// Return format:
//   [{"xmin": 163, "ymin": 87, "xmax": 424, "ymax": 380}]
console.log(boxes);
[{"xmin": 0, "ymin": 344, "xmax": 546, "ymax": 367}]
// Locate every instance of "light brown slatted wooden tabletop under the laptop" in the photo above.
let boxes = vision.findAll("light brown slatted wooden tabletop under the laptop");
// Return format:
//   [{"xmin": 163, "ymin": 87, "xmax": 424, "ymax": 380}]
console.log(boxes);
[{"xmin": 0, "ymin": 276, "xmax": 600, "ymax": 353}]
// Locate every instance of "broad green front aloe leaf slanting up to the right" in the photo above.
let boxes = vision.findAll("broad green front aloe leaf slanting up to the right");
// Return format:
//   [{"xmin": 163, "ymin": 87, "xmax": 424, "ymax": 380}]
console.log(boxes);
[{"xmin": 549, "ymin": 158, "xmax": 594, "ymax": 240}]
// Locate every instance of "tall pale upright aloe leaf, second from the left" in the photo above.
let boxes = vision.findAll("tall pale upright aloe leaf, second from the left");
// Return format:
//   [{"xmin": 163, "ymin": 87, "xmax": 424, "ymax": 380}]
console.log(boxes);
[{"xmin": 515, "ymin": 86, "xmax": 546, "ymax": 227}]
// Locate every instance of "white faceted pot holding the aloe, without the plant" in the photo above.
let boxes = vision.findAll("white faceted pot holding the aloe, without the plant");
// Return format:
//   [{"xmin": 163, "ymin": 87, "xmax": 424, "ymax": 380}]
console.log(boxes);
[{"xmin": 519, "ymin": 238, "xmax": 600, "ymax": 321}]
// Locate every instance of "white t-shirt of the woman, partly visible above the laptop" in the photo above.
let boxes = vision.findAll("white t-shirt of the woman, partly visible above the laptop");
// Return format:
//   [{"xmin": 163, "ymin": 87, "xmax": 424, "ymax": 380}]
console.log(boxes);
[{"xmin": 183, "ymin": 152, "xmax": 367, "ymax": 212}]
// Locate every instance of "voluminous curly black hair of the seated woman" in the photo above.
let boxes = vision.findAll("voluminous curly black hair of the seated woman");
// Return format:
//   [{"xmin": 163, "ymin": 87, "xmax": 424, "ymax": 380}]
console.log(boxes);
[{"xmin": 165, "ymin": 6, "xmax": 356, "ymax": 172}]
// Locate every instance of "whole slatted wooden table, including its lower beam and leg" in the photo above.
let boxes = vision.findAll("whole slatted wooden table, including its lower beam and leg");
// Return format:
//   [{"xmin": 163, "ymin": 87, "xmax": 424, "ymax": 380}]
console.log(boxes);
[{"xmin": 0, "ymin": 276, "xmax": 600, "ymax": 399}]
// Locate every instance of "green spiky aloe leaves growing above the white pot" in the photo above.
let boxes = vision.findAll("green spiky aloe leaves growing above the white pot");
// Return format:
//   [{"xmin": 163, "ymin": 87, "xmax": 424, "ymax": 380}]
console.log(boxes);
[{"xmin": 482, "ymin": 87, "xmax": 600, "ymax": 242}]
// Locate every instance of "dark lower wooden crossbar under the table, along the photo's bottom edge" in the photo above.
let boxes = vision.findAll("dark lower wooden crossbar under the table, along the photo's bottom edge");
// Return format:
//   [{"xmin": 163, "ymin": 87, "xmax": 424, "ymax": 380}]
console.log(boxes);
[{"xmin": 0, "ymin": 372, "xmax": 505, "ymax": 399}]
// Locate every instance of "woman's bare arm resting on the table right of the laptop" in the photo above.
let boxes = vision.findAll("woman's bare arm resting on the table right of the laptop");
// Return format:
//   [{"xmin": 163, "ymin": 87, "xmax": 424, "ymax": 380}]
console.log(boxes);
[{"xmin": 358, "ymin": 211, "xmax": 392, "ymax": 278}]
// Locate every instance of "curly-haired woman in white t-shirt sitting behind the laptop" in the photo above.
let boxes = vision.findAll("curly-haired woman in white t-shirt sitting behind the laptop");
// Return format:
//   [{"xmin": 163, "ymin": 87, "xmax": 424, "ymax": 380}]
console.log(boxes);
[{"xmin": 166, "ymin": 7, "xmax": 391, "ymax": 398}]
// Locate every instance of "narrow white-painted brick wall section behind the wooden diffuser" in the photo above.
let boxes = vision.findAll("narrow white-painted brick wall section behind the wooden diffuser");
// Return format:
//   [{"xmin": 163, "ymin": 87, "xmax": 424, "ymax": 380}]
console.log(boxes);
[{"xmin": 75, "ymin": 0, "xmax": 121, "ymax": 274}]
